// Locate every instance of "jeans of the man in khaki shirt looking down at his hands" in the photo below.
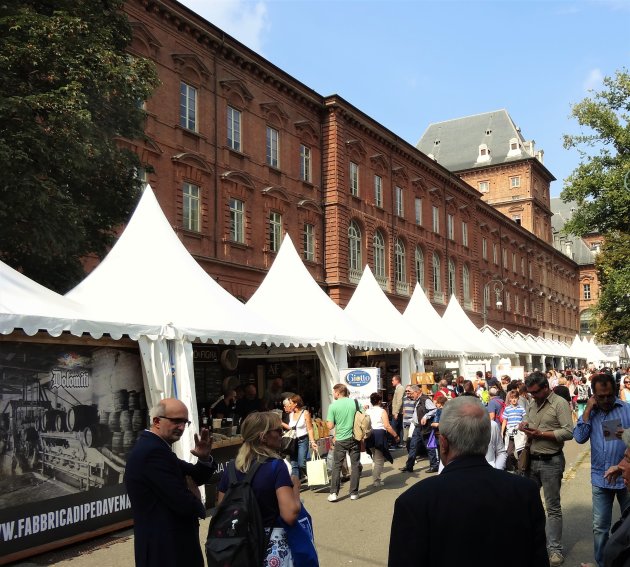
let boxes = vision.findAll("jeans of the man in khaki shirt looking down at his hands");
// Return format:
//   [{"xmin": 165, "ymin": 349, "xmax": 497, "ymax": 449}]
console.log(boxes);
[{"xmin": 529, "ymin": 453, "xmax": 565, "ymax": 554}]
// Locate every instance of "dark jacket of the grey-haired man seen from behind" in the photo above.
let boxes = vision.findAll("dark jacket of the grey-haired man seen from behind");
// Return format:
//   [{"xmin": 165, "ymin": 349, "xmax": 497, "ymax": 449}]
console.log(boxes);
[{"xmin": 388, "ymin": 457, "xmax": 549, "ymax": 567}]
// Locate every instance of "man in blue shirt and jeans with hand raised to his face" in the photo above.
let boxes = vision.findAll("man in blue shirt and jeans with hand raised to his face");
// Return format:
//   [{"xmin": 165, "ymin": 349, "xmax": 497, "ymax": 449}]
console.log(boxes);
[{"xmin": 573, "ymin": 374, "xmax": 630, "ymax": 567}]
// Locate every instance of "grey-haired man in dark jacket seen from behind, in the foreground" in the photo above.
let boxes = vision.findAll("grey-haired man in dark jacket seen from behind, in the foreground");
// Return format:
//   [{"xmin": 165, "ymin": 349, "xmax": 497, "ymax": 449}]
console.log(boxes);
[{"xmin": 388, "ymin": 396, "xmax": 549, "ymax": 567}]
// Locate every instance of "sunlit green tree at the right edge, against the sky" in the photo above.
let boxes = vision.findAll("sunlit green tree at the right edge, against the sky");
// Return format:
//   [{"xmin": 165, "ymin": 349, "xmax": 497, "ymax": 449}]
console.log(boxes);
[{"xmin": 561, "ymin": 69, "xmax": 630, "ymax": 343}]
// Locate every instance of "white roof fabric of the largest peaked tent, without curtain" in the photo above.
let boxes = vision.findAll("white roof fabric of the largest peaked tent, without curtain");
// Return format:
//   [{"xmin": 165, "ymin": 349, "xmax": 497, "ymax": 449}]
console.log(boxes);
[{"xmin": 66, "ymin": 186, "xmax": 303, "ymax": 344}]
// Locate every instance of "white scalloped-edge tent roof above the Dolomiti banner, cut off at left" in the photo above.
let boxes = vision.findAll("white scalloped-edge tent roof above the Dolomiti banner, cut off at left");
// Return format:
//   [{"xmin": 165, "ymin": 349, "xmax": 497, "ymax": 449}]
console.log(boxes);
[{"xmin": 0, "ymin": 262, "xmax": 156, "ymax": 339}]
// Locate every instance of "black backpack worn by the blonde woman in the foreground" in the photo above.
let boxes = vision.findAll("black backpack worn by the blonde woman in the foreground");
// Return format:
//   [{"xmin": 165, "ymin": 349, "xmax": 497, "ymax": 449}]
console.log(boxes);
[{"xmin": 206, "ymin": 461, "xmax": 269, "ymax": 567}]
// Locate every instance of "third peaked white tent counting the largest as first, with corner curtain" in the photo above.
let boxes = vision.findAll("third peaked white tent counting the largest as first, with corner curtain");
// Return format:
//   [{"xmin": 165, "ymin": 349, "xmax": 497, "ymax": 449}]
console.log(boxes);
[{"xmin": 344, "ymin": 265, "xmax": 417, "ymax": 384}]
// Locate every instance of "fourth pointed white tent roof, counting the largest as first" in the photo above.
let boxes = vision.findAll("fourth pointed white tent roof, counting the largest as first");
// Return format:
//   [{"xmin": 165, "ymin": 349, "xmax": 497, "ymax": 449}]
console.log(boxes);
[{"xmin": 403, "ymin": 282, "xmax": 470, "ymax": 356}]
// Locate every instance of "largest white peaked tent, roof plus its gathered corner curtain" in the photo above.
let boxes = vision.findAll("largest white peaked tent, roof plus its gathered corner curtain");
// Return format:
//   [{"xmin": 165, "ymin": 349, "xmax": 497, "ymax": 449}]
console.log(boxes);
[{"xmin": 66, "ymin": 186, "xmax": 304, "ymax": 458}]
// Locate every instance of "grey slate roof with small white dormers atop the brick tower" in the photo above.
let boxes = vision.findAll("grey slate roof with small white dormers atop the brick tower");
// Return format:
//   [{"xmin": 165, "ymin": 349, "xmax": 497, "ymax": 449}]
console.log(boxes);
[{"xmin": 416, "ymin": 109, "xmax": 553, "ymax": 177}]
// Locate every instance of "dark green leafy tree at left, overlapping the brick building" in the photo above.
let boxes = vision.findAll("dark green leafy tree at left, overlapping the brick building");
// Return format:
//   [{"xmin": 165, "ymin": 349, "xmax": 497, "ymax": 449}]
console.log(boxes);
[{"xmin": 0, "ymin": 0, "xmax": 158, "ymax": 292}]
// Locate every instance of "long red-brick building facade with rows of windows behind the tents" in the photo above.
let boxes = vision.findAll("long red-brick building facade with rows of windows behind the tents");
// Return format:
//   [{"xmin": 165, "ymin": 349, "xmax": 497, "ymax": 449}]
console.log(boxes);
[{"xmin": 125, "ymin": 0, "xmax": 578, "ymax": 341}]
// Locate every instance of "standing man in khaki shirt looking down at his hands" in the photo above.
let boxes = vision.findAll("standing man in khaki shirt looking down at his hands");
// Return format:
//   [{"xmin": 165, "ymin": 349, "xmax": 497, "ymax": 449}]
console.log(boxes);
[{"xmin": 519, "ymin": 372, "xmax": 573, "ymax": 567}]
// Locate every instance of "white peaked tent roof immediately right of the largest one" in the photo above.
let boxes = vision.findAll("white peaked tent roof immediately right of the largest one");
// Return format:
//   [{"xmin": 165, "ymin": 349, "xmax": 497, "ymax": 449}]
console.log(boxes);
[{"xmin": 247, "ymin": 234, "xmax": 400, "ymax": 349}]
